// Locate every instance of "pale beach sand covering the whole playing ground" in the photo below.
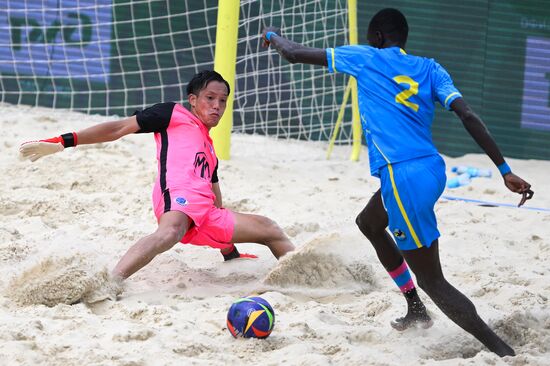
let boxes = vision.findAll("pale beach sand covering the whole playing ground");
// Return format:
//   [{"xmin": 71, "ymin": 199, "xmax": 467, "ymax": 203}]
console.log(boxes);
[{"xmin": 0, "ymin": 105, "xmax": 550, "ymax": 366}]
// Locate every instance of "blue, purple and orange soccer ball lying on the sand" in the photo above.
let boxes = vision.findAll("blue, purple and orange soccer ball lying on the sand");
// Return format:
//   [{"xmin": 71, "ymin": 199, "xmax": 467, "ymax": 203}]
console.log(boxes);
[{"xmin": 227, "ymin": 296, "xmax": 275, "ymax": 338}]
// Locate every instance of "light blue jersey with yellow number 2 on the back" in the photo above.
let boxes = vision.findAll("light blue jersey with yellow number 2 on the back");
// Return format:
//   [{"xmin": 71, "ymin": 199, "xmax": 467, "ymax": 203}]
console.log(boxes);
[{"xmin": 326, "ymin": 46, "xmax": 462, "ymax": 177}]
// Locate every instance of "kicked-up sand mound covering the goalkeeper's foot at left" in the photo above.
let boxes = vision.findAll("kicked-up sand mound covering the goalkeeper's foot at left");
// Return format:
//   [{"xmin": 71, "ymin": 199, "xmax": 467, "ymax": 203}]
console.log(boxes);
[{"xmin": 7, "ymin": 254, "xmax": 119, "ymax": 306}]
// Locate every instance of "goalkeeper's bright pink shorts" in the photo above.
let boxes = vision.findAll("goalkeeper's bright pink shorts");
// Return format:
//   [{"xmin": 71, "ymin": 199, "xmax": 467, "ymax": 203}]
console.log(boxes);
[{"xmin": 153, "ymin": 192, "xmax": 235, "ymax": 249}]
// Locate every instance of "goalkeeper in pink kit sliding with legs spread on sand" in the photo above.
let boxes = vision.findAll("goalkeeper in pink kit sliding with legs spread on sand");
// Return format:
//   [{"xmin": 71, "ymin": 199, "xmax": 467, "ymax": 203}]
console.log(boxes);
[{"xmin": 20, "ymin": 71, "xmax": 294, "ymax": 280}]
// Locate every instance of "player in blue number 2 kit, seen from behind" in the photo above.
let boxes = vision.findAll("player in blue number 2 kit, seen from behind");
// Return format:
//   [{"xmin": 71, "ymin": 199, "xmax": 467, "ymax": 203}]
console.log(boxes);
[{"xmin": 262, "ymin": 9, "xmax": 533, "ymax": 356}]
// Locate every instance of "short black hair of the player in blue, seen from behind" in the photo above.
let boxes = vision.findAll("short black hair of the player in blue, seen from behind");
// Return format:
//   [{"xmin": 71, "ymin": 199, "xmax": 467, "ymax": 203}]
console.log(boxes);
[{"xmin": 368, "ymin": 8, "xmax": 409, "ymax": 45}]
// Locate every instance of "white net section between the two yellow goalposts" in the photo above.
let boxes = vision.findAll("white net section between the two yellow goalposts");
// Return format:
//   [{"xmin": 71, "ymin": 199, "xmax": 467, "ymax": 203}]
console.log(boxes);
[{"xmin": 234, "ymin": 0, "xmax": 351, "ymax": 141}]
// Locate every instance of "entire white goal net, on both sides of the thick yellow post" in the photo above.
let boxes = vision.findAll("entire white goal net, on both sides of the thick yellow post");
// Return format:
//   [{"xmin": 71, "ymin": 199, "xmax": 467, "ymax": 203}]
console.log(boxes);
[{"xmin": 0, "ymin": 0, "xmax": 351, "ymax": 142}]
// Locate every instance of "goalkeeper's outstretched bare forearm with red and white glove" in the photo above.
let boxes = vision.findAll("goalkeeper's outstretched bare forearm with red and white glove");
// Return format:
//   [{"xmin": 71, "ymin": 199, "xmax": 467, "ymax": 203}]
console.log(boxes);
[{"xmin": 19, "ymin": 116, "xmax": 139, "ymax": 161}]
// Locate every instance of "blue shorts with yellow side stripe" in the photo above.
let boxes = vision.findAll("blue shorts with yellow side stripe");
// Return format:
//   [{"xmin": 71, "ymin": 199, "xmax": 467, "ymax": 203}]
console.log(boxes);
[{"xmin": 380, "ymin": 155, "xmax": 447, "ymax": 250}]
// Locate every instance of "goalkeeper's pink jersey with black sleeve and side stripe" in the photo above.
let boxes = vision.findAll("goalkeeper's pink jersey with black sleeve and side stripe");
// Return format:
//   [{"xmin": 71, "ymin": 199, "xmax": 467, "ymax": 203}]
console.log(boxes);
[{"xmin": 136, "ymin": 103, "xmax": 218, "ymax": 226}]
